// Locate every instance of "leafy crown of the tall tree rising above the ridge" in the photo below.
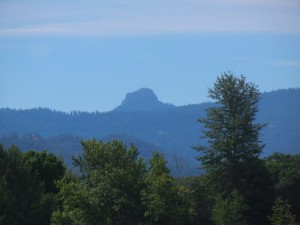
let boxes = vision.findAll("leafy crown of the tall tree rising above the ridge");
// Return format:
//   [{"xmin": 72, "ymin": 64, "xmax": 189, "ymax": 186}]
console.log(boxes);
[{"xmin": 196, "ymin": 73, "xmax": 264, "ymax": 194}]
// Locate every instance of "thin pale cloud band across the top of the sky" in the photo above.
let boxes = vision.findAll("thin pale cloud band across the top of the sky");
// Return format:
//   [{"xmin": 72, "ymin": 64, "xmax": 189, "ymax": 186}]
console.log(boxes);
[{"xmin": 0, "ymin": 0, "xmax": 300, "ymax": 36}]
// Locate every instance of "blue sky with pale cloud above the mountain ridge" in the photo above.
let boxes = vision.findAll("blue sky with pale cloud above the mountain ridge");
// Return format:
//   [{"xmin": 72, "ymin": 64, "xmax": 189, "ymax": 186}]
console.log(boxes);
[{"xmin": 0, "ymin": 0, "xmax": 300, "ymax": 112}]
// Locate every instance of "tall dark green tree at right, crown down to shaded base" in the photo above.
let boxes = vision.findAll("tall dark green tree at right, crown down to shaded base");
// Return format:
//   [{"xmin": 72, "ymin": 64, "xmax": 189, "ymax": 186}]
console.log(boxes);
[{"xmin": 196, "ymin": 73, "xmax": 272, "ymax": 224}]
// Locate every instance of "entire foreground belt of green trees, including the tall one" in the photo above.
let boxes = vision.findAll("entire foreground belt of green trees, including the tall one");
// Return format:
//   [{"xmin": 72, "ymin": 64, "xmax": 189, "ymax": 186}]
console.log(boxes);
[{"xmin": 0, "ymin": 73, "xmax": 300, "ymax": 225}]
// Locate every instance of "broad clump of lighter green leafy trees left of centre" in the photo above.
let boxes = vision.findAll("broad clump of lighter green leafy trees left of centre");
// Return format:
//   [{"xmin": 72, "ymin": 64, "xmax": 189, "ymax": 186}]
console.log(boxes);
[{"xmin": 52, "ymin": 140, "xmax": 188, "ymax": 225}]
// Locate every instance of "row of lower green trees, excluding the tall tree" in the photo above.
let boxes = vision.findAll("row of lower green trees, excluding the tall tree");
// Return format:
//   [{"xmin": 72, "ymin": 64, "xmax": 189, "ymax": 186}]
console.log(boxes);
[{"xmin": 0, "ymin": 140, "xmax": 300, "ymax": 225}]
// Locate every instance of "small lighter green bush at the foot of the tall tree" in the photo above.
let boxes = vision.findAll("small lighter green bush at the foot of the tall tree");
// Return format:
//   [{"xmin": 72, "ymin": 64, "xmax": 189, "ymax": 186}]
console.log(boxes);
[{"xmin": 212, "ymin": 190, "xmax": 248, "ymax": 225}]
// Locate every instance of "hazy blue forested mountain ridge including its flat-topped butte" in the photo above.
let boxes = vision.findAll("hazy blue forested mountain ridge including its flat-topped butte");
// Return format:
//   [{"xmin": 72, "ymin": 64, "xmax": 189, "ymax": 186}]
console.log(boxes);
[{"xmin": 0, "ymin": 88, "xmax": 300, "ymax": 174}]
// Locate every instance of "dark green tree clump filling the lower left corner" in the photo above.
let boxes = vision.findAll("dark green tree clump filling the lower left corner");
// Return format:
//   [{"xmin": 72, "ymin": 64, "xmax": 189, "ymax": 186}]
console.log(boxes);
[{"xmin": 0, "ymin": 146, "xmax": 65, "ymax": 225}]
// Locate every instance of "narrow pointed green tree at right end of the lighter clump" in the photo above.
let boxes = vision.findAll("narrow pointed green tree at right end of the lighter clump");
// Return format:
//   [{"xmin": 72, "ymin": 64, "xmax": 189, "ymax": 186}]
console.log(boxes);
[{"xmin": 142, "ymin": 152, "xmax": 187, "ymax": 225}]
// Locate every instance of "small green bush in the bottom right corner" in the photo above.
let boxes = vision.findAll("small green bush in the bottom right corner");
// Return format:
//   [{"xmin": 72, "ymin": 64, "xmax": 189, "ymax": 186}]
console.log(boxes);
[{"xmin": 269, "ymin": 197, "xmax": 298, "ymax": 225}]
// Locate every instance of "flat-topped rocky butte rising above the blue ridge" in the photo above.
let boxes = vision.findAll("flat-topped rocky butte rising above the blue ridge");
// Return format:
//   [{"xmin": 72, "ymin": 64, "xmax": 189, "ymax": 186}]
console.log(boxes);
[{"xmin": 114, "ymin": 88, "xmax": 174, "ymax": 112}]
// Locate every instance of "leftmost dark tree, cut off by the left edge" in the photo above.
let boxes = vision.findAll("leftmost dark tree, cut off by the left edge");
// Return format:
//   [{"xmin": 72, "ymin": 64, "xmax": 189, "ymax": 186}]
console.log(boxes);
[{"xmin": 0, "ymin": 145, "xmax": 43, "ymax": 225}]
